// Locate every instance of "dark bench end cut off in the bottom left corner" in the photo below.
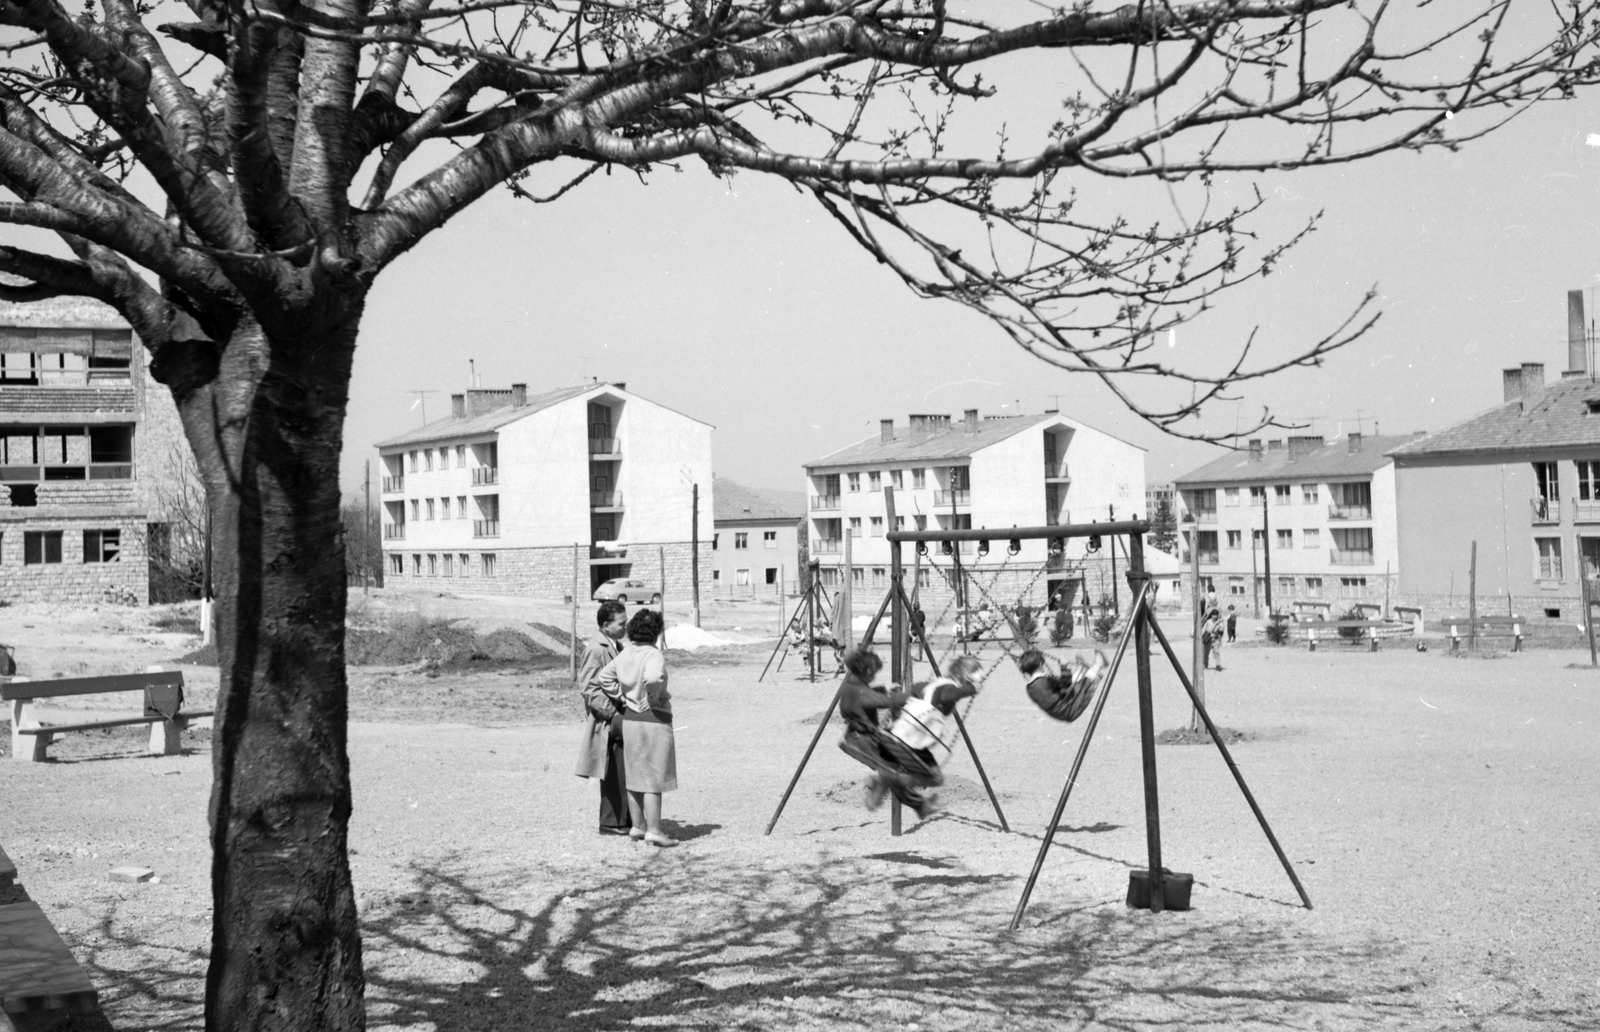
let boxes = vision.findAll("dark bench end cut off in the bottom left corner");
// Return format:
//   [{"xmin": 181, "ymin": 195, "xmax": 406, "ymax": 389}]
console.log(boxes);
[{"xmin": 0, "ymin": 851, "xmax": 99, "ymax": 1032}]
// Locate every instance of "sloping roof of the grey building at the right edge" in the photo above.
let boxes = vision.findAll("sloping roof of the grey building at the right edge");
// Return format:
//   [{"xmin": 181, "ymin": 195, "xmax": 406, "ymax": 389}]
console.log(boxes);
[{"xmin": 1390, "ymin": 376, "xmax": 1600, "ymax": 461}]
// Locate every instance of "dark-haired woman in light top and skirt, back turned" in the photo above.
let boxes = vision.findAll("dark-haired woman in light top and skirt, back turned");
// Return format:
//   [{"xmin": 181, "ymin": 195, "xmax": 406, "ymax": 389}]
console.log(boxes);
[{"xmin": 600, "ymin": 610, "xmax": 678, "ymax": 848}]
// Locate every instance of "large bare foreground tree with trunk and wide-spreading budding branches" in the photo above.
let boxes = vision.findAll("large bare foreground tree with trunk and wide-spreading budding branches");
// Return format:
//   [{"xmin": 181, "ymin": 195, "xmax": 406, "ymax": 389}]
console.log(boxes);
[{"xmin": 0, "ymin": 0, "xmax": 1597, "ymax": 1029}]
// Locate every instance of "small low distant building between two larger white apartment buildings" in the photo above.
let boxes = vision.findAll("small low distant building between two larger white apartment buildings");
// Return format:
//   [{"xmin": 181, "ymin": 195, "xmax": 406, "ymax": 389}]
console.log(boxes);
[{"xmin": 710, "ymin": 477, "xmax": 805, "ymax": 598}]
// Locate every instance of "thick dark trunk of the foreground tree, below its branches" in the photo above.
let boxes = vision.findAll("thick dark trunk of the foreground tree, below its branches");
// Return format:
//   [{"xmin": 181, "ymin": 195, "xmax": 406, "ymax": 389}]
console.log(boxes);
[{"xmin": 155, "ymin": 307, "xmax": 365, "ymax": 1030}]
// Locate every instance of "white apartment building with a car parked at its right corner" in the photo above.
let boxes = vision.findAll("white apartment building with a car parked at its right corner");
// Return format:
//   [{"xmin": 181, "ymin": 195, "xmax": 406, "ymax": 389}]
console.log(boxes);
[{"xmin": 378, "ymin": 382, "xmax": 715, "ymax": 598}]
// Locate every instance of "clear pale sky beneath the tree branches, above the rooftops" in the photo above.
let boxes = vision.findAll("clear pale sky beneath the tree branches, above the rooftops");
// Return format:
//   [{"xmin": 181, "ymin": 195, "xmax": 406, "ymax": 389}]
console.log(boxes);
[{"xmin": 344, "ymin": 91, "xmax": 1600, "ymax": 505}]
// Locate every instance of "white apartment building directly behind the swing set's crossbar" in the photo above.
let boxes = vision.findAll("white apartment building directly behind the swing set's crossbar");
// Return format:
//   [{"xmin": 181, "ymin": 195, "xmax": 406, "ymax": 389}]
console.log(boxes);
[{"xmin": 805, "ymin": 410, "xmax": 1144, "ymax": 605}]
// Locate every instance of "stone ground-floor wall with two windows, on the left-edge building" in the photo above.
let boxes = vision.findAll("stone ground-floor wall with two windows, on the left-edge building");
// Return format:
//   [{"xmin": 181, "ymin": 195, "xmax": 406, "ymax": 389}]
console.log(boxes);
[{"xmin": 0, "ymin": 517, "xmax": 150, "ymax": 605}]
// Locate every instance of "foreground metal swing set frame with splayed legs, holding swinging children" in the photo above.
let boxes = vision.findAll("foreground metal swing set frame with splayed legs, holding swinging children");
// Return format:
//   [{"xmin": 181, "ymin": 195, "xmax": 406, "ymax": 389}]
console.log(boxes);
[{"xmin": 766, "ymin": 486, "xmax": 1312, "ymax": 930}]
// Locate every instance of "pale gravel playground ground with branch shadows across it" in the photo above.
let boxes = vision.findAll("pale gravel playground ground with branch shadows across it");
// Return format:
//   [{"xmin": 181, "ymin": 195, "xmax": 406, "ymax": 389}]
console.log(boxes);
[{"xmin": 0, "ymin": 600, "xmax": 1600, "ymax": 1032}]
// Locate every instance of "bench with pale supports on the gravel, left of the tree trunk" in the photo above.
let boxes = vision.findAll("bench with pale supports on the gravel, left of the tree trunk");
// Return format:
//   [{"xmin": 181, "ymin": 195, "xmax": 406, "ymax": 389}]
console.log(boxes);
[{"xmin": 0, "ymin": 670, "xmax": 211, "ymax": 762}]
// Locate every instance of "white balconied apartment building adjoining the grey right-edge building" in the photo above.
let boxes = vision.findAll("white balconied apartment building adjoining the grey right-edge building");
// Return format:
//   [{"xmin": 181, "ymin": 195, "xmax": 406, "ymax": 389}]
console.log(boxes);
[{"xmin": 1176, "ymin": 434, "xmax": 1410, "ymax": 610}]
